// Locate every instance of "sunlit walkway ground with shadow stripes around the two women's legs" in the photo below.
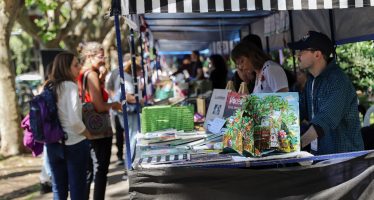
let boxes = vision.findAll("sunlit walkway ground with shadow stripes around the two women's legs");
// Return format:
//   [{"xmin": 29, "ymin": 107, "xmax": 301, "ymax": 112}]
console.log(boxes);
[{"xmin": 0, "ymin": 146, "xmax": 129, "ymax": 200}]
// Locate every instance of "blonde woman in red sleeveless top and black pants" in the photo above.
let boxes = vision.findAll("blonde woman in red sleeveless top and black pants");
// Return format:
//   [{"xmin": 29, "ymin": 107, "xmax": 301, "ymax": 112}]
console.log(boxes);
[{"xmin": 78, "ymin": 42, "xmax": 121, "ymax": 200}]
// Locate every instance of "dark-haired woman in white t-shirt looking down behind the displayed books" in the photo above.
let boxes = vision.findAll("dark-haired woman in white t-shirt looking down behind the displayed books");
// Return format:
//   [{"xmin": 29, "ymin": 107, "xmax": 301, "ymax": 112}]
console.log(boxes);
[{"xmin": 231, "ymin": 43, "xmax": 288, "ymax": 93}]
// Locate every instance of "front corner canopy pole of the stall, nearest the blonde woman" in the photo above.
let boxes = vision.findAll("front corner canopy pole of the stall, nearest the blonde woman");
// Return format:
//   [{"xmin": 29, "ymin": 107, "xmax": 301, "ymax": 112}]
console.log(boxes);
[{"xmin": 112, "ymin": 5, "xmax": 132, "ymax": 170}]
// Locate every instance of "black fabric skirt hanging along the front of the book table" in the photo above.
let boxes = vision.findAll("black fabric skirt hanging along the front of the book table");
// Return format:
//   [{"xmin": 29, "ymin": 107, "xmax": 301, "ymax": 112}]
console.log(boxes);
[{"xmin": 129, "ymin": 153, "xmax": 374, "ymax": 200}]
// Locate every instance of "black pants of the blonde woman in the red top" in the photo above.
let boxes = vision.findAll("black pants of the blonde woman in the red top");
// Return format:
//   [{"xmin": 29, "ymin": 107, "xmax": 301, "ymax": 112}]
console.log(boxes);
[{"xmin": 86, "ymin": 137, "xmax": 113, "ymax": 200}]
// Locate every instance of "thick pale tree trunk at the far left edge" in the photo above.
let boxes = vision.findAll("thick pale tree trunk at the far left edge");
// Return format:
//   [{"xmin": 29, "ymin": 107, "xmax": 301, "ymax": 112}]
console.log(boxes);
[{"xmin": 0, "ymin": 0, "xmax": 22, "ymax": 156}]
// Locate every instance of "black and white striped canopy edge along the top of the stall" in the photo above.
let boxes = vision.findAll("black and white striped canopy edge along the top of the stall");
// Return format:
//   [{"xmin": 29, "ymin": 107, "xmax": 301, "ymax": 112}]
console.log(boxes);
[{"xmin": 121, "ymin": 0, "xmax": 374, "ymax": 15}]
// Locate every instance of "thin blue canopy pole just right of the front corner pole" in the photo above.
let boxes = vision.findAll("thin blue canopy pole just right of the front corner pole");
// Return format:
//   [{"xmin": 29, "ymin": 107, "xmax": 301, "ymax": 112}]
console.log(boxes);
[{"xmin": 130, "ymin": 29, "xmax": 141, "ymax": 132}]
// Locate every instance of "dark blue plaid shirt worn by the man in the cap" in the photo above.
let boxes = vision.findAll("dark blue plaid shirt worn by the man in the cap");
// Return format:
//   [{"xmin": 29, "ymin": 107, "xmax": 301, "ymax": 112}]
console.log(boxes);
[{"xmin": 300, "ymin": 61, "xmax": 364, "ymax": 154}]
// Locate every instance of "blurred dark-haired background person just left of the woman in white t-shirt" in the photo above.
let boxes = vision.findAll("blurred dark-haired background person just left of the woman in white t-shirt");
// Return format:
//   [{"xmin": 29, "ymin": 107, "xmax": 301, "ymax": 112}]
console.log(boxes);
[{"xmin": 209, "ymin": 54, "xmax": 228, "ymax": 89}]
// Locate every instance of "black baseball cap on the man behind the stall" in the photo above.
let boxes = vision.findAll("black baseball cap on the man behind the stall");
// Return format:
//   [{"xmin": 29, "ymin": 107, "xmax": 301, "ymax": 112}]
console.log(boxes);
[{"xmin": 287, "ymin": 31, "xmax": 334, "ymax": 57}]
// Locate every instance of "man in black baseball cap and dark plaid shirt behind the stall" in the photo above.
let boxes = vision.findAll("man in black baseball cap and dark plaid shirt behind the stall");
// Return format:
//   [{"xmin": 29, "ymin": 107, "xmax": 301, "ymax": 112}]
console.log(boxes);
[{"xmin": 288, "ymin": 31, "xmax": 364, "ymax": 155}]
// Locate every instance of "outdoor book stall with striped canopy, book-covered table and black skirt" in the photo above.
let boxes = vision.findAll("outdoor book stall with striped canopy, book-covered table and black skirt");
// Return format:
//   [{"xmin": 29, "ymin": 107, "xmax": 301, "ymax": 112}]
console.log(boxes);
[{"xmin": 112, "ymin": 0, "xmax": 374, "ymax": 199}]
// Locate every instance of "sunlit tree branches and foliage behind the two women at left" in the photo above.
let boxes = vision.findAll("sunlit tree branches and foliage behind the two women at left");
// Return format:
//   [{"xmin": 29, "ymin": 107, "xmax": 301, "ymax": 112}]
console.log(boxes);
[{"xmin": 11, "ymin": 0, "xmax": 128, "ymax": 74}]
